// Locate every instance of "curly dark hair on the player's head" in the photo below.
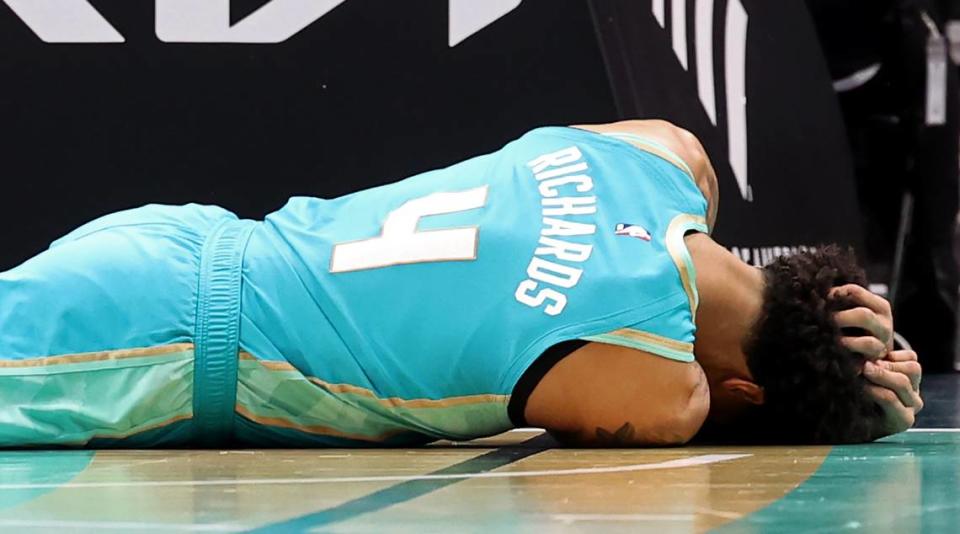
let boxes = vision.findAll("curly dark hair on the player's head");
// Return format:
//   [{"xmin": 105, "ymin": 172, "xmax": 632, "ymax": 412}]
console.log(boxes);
[{"xmin": 744, "ymin": 245, "xmax": 881, "ymax": 443}]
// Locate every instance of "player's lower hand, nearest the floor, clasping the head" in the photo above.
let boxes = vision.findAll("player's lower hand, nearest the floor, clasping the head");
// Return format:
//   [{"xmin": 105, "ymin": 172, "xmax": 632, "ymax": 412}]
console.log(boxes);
[{"xmin": 863, "ymin": 350, "xmax": 923, "ymax": 437}]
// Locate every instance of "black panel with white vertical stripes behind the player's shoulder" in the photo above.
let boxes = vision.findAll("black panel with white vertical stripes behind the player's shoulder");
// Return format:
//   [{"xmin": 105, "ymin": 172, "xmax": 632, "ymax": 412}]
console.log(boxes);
[{"xmin": 593, "ymin": 0, "xmax": 860, "ymax": 264}]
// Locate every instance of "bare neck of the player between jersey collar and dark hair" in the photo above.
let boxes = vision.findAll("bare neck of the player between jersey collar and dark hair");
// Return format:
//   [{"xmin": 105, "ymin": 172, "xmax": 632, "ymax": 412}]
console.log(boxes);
[{"xmin": 686, "ymin": 234, "xmax": 764, "ymax": 382}]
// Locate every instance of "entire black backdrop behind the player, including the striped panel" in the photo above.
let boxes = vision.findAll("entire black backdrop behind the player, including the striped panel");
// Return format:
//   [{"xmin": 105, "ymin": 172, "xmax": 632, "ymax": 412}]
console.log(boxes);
[{"xmin": 0, "ymin": 0, "xmax": 859, "ymax": 269}]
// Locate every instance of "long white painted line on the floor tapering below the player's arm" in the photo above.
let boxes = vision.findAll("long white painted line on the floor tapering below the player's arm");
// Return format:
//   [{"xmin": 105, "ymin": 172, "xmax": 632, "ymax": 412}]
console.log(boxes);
[{"xmin": 0, "ymin": 454, "xmax": 753, "ymax": 490}]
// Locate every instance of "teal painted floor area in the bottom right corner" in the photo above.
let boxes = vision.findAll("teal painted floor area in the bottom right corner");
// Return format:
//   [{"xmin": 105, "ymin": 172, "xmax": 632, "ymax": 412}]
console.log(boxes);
[{"xmin": 713, "ymin": 428, "xmax": 960, "ymax": 534}]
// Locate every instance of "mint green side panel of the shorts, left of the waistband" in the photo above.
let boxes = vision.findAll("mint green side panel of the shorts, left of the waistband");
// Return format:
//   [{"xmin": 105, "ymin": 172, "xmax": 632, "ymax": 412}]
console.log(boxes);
[{"xmin": 0, "ymin": 343, "xmax": 193, "ymax": 447}]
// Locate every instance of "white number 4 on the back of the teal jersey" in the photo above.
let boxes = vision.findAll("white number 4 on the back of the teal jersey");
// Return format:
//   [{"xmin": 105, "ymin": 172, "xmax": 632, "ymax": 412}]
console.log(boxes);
[{"xmin": 330, "ymin": 186, "xmax": 496, "ymax": 273}]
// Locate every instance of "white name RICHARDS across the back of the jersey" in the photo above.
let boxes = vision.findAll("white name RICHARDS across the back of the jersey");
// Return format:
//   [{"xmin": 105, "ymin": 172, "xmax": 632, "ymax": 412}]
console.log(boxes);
[{"xmin": 514, "ymin": 146, "xmax": 597, "ymax": 315}]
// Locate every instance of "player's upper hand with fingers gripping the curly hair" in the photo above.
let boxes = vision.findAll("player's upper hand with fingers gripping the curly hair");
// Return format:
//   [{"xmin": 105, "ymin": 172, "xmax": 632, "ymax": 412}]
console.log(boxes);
[{"xmin": 830, "ymin": 284, "xmax": 893, "ymax": 360}]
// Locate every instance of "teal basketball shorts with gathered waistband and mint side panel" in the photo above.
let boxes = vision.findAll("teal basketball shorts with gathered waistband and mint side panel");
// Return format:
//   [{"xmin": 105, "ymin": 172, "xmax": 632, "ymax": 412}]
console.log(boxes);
[{"xmin": 0, "ymin": 205, "xmax": 256, "ymax": 447}]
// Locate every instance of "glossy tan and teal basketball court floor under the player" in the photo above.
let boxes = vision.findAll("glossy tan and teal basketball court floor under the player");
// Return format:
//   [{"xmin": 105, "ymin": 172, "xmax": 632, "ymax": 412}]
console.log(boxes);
[{"xmin": 0, "ymin": 377, "xmax": 960, "ymax": 534}]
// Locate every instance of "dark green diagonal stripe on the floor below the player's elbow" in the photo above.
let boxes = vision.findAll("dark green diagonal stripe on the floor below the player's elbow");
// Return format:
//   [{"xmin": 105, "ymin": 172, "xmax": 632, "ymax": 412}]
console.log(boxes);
[{"xmin": 250, "ymin": 435, "xmax": 555, "ymax": 533}]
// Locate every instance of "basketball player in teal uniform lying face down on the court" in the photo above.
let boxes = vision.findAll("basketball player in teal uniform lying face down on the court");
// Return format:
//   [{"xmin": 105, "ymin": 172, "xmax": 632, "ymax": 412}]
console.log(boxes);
[{"xmin": 0, "ymin": 121, "xmax": 922, "ymax": 447}]
